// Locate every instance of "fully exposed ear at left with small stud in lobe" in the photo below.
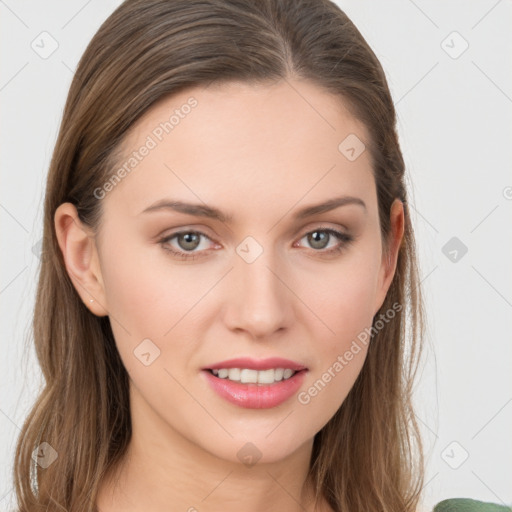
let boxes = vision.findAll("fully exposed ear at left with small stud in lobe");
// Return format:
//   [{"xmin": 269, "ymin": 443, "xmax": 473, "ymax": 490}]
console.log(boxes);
[{"xmin": 54, "ymin": 203, "xmax": 108, "ymax": 316}]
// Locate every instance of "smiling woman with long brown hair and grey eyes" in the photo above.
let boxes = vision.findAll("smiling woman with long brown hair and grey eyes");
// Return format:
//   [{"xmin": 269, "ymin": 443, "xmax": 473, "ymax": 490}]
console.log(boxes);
[{"xmin": 10, "ymin": 0, "xmax": 506, "ymax": 512}]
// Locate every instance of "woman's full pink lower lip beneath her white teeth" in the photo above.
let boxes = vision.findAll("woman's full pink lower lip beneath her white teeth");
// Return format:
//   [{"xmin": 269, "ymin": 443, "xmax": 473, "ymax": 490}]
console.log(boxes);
[{"xmin": 202, "ymin": 370, "xmax": 307, "ymax": 409}]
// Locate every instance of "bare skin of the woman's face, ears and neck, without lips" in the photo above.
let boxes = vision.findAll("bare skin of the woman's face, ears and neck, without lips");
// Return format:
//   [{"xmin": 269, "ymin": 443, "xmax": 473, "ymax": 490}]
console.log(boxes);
[{"xmin": 55, "ymin": 80, "xmax": 404, "ymax": 512}]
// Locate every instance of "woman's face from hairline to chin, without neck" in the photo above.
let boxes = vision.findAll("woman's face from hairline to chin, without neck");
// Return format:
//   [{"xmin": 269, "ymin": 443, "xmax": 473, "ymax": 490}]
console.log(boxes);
[{"xmin": 74, "ymin": 81, "xmax": 402, "ymax": 462}]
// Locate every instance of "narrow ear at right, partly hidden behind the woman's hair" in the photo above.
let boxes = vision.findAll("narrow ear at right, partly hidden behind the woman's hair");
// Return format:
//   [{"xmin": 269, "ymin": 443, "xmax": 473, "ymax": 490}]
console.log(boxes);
[{"xmin": 373, "ymin": 199, "xmax": 404, "ymax": 316}]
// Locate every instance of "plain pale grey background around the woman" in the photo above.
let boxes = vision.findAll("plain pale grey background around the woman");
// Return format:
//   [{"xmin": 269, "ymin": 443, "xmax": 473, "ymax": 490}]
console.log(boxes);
[{"xmin": 0, "ymin": 0, "xmax": 512, "ymax": 511}]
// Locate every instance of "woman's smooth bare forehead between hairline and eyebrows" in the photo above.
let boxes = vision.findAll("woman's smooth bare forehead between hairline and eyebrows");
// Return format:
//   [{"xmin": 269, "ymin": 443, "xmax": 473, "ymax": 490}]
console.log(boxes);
[{"xmin": 106, "ymin": 80, "xmax": 375, "ymax": 222}]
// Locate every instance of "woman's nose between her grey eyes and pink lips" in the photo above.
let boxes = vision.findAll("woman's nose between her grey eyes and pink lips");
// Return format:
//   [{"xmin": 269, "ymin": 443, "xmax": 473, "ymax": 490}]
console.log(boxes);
[{"xmin": 224, "ymin": 247, "xmax": 294, "ymax": 340}]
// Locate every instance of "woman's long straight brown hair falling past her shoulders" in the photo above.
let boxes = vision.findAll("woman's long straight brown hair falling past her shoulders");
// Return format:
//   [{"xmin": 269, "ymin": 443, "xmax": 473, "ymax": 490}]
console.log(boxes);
[{"xmin": 14, "ymin": 0, "xmax": 424, "ymax": 512}]
